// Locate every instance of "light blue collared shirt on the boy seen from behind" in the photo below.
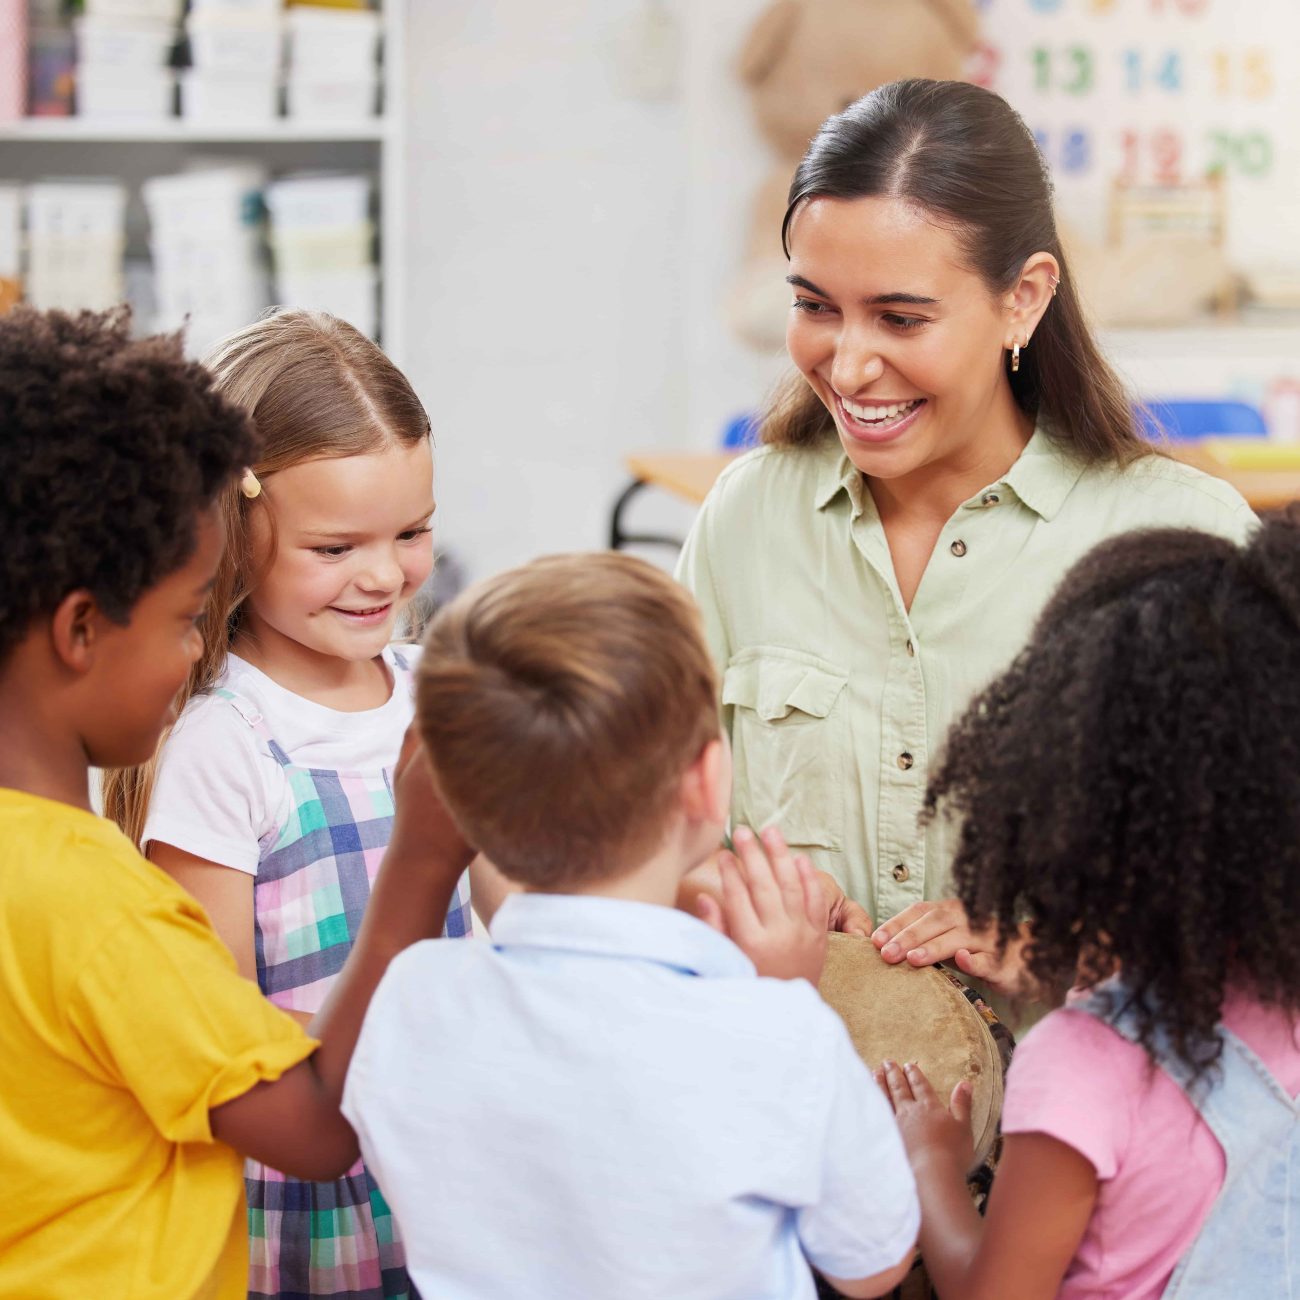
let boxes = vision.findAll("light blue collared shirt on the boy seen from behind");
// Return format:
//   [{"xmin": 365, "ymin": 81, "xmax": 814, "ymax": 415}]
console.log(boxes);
[{"xmin": 343, "ymin": 894, "xmax": 919, "ymax": 1300}]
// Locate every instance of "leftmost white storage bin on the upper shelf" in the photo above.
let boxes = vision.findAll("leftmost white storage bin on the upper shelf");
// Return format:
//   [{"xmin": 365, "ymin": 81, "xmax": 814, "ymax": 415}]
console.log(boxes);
[{"xmin": 74, "ymin": 0, "xmax": 181, "ymax": 121}]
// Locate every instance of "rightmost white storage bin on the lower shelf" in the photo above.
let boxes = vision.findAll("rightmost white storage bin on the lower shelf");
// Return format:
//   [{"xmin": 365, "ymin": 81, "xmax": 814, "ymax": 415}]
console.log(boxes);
[{"xmin": 267, "ymin": 173, "xmax": 380, "ymax": 338}]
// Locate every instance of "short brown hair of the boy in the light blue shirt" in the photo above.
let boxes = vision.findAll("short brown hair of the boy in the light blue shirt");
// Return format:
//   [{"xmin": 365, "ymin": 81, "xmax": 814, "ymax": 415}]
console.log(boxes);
[{"xmin": 417, "ymin": 553, "xmax": 719, "ymax": 889}]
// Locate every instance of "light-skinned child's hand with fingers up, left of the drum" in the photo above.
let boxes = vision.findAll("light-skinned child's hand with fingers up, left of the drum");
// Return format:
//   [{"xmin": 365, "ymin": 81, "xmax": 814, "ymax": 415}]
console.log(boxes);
[{"xmin": 696, "ymin": 827, "xmax": 828, "ymax": 987}]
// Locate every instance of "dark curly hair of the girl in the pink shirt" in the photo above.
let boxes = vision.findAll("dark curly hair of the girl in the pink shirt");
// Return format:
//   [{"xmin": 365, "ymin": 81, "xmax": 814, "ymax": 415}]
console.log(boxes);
[{"xmin": 927, "ymin": 514, "xmax": 1300, "ymax": 1066}]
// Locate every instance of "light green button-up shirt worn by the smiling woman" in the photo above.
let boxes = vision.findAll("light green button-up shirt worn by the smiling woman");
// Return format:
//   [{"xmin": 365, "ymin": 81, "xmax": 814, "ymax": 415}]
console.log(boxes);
[{"xmin": 677, "ymin": 430, "xmax": 1255, "ymax": 920}]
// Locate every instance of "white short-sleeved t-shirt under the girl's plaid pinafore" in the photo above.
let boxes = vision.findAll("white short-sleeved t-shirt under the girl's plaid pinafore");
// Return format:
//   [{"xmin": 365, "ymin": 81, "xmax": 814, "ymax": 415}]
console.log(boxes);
[{"xmin": 143, "ymin": 646, "xmax": 420, "ymax": 875}]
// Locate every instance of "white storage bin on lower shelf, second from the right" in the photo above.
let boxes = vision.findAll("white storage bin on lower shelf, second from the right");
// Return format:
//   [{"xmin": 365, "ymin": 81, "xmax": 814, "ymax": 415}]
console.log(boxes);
[{"xmin": 143, "ymin": 163, "xmax": 269, "ymax": 355}]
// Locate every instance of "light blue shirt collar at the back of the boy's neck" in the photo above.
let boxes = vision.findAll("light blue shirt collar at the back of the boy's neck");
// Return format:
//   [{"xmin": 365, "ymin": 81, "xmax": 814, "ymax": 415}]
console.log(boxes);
[{"xmin": 488, "ymin": 893, "xmax": 754, "ymax": 978}]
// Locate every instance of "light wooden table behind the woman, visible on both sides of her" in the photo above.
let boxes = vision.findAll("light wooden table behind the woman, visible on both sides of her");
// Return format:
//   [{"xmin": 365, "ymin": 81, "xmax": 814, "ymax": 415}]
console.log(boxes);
[{"xmin": 610, "ymin": 443, "xmax": 1300, "ymax": 550}]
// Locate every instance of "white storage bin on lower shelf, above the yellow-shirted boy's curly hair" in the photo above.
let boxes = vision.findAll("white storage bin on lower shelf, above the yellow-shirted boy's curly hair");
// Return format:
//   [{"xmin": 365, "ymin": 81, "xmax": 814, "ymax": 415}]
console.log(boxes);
[{"xmin": 26, "ymin": 181, "xmax": 126, "ymax": 311}]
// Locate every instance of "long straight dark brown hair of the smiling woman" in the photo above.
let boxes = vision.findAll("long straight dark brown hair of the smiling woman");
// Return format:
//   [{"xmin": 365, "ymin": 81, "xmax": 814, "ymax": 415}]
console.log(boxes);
[{"xmin": 762, "ymin": 79, "xmax": 1153, "ymax": 463}]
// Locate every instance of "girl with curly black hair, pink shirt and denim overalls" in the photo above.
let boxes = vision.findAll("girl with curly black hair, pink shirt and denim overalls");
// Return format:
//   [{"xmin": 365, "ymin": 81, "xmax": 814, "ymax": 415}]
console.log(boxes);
[{"xmin": 881, "ymin": 517, "xmax": 1300, "ymax": 1300}]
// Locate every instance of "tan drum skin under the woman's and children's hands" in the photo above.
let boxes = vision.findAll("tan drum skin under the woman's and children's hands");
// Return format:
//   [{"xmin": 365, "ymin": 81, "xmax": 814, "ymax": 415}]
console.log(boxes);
[{"xmin": 820, "ymin": 935, "xmax": 1002, "ymax": 1165}]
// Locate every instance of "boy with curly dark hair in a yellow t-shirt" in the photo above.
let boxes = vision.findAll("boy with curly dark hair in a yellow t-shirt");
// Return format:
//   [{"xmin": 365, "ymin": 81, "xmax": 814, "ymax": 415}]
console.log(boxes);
[{"xmin": 0, "ymin": 309, "xmax": 468, "ymax": 1300}]
